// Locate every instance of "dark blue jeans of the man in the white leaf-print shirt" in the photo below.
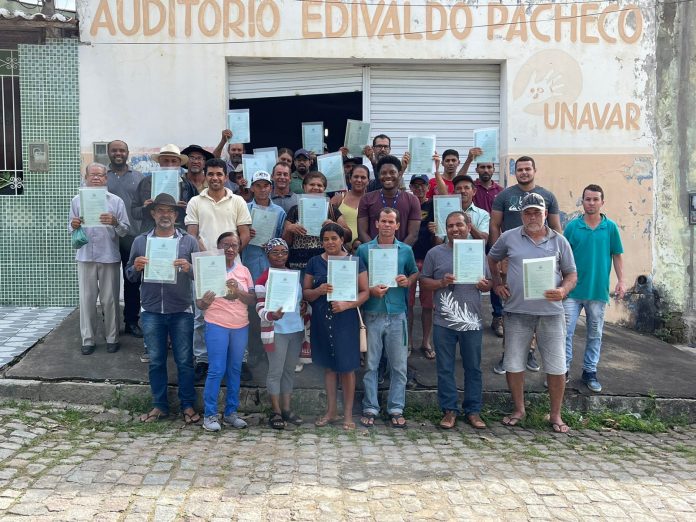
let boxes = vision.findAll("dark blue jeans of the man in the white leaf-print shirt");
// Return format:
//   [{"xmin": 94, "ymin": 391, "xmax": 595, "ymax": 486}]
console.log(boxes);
[{"xmin": 433, "ymin": 325, "xmax": 483, "ymax": 415}]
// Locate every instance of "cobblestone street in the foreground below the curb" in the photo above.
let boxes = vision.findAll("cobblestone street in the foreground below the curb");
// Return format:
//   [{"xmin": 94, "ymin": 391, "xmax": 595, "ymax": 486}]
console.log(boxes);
[{"xmin": 0, "ymin": 403, "xmax": 696, "ymax": 521}]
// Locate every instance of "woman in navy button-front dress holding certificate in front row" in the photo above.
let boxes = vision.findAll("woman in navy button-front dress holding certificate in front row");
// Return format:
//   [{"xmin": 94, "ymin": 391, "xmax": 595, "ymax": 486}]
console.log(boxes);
[{"xmin": 302, "ymin": 223, "xmax": 369, "ymax": 430}]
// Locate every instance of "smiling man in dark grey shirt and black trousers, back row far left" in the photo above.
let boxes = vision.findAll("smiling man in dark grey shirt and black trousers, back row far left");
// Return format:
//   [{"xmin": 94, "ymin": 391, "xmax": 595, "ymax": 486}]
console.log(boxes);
[{"xmin": 106, "ymin": 140, "xmax": 143, "ymax": 337}]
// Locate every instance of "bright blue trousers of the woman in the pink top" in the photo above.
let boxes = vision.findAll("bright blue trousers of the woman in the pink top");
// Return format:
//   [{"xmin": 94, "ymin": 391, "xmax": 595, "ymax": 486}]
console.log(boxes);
[{"xmin": 203, "ymin": 321, "xmax": 249, "ymax": 417}]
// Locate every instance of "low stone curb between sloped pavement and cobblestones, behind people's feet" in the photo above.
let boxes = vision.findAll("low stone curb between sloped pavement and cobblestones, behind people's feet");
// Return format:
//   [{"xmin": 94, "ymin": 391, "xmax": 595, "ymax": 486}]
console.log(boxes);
[{"xmin": 0, "ymin": 379, "xmax": 696, "ymax": 422}]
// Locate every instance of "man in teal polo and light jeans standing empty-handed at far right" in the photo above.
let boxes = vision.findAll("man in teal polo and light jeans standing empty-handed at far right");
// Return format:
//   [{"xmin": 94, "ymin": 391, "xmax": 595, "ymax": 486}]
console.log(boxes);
[{"xmin": 563, "ymin": 185, "xmax": 626, "ymax": 392}]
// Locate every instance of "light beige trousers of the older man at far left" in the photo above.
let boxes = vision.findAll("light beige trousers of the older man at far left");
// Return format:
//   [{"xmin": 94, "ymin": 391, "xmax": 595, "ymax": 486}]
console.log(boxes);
[{"xmin": 77, "ymin": 261, "xmax": 121, "ymax": 346}]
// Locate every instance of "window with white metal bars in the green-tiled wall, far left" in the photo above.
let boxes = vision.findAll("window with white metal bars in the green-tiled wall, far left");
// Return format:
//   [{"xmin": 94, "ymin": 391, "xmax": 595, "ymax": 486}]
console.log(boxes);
[{"xmin": 0, "ymin": 49, "xmax": 24, "ymax": 196}]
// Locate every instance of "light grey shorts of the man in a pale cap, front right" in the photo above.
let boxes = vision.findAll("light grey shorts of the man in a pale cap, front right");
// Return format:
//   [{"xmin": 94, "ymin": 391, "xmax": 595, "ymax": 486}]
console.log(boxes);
[{"xmin": 503, "ymin": 312, "xmax": 566, "ymax": 375}]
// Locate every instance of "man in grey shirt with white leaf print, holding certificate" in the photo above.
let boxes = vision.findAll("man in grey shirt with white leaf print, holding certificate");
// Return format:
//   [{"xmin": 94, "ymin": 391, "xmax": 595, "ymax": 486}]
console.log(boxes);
[{"xmin": 420, "ymin": 210, "xmax": 492, "ymax": 429}]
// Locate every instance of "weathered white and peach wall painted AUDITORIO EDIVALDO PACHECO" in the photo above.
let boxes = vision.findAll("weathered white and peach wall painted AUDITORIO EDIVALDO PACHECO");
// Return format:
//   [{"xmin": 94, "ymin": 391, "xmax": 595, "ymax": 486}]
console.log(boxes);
[{"xmin": 78, "ymin": 0, "xmax": 656, "ymax": 316}]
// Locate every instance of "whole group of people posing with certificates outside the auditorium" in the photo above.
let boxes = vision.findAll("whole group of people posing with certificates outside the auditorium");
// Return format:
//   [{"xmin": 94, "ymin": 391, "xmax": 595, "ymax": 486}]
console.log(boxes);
[{"xmin": 69, "ymin": 130, "xmax": 625, "ymax": 433}]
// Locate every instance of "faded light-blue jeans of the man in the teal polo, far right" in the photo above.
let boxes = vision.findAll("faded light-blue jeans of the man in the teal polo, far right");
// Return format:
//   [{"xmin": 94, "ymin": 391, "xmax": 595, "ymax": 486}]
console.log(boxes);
[{"xmin": 563, "ymin": 297, "xmax": 607, "ymax": 372}]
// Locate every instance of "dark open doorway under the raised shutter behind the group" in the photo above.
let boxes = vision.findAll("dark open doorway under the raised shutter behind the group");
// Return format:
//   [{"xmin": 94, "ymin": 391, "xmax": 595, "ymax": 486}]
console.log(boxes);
[{"xmin": 230, "ymin": 92, "xmax": 362, "ymax": 153}]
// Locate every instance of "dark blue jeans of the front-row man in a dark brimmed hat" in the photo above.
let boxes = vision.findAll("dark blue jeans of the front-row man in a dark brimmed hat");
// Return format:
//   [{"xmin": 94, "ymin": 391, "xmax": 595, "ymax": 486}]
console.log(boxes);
[{"xmin": 140, "ymin": 312, "xmax": 195, "ymax": 413}]
